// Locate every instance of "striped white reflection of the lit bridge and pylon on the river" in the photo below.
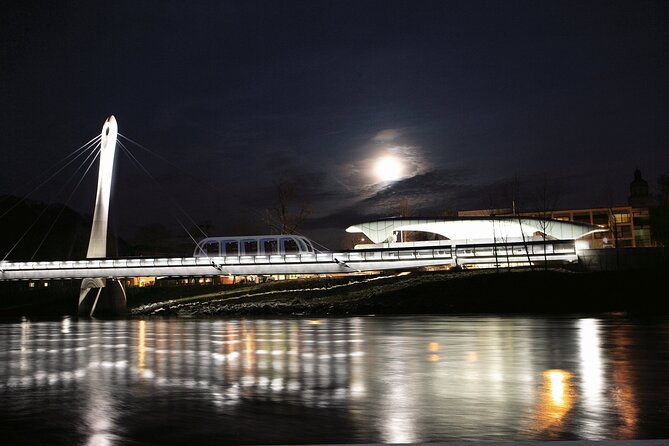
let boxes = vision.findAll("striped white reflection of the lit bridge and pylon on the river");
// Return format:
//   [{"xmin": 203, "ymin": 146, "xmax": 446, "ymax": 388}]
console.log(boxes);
[{"xmin": 3, "ymin": 318, "xmax": 367, "ymax": 444}]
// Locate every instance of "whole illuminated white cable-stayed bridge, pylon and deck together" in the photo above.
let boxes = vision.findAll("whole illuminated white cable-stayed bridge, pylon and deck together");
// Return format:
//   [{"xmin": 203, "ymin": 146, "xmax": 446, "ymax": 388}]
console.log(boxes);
[{"xmin": 0, "ymin": 116, "xmax": 592, "ymax": 316}]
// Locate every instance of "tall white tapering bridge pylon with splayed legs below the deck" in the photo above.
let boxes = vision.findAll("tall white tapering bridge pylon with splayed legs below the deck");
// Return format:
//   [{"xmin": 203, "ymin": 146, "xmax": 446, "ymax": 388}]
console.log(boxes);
[{"xmin": 79, "ymin": 115, "xmax": 127, "ymax": 316}]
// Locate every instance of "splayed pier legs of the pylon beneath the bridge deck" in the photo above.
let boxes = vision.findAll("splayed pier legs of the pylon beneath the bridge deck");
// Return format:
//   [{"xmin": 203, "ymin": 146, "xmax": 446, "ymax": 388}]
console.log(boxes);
[{"xmin": 78, "ymin": 278, "xmax": 127, "ymax": 317}]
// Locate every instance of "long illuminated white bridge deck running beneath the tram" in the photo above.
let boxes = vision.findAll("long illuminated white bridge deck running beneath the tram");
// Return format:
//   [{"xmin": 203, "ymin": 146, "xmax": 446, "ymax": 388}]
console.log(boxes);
[{"xmin": 0, "ymin": 241, "xmax": 578, "ymax": 281}]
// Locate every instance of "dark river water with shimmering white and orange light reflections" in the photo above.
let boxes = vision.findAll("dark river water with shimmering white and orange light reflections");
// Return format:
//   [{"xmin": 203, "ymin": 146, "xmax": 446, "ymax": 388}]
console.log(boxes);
[{"xmin": 0, "ymin": 316, "xmax": 669, "ymax": 445}]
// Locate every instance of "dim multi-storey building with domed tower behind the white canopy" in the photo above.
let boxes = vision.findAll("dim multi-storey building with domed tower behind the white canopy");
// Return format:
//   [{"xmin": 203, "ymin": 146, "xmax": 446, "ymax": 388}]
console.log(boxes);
[{"xmin": 458, "ymin": 169, "xmax": 657, "ymax": 248}]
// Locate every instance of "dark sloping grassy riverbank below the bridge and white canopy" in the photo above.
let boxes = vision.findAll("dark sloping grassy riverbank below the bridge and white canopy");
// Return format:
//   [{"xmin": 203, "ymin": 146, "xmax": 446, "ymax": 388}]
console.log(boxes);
[{"xmin": 128, "ymin": 268, "xmax": 669, "ymax": 317}]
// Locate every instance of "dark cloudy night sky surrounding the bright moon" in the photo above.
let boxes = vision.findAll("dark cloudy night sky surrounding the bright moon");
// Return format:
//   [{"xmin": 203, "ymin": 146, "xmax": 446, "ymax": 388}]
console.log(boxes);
[{"xmin": 0, "ymin": 0, "xmax": 669, "ymax": 248}]
